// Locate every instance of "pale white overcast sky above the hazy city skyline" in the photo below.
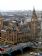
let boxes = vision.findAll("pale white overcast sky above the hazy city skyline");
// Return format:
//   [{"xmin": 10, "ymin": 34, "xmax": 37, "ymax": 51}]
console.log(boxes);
[{"xmin": 0, "ymin": 0, "xmax": 42, "ymax": 11}]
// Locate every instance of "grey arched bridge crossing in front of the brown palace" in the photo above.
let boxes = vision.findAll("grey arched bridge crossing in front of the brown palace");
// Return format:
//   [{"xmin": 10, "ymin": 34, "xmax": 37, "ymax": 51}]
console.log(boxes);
[{"xmin": 0, "ymin": 42, "xmax": 40, "ymax": 56}]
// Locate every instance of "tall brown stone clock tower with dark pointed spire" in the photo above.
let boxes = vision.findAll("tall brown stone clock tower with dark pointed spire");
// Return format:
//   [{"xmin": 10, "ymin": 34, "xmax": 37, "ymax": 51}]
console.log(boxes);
[{"xmin": 31, "ymin": 9, "xmax": 38, "ymax": 40}]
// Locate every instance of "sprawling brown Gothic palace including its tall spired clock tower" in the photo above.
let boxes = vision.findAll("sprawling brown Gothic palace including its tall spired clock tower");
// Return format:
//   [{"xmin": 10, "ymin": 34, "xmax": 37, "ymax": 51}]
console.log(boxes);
[{"xmin": 0, "ymin": 9, "xmax": 41, "ymax": 44}]
